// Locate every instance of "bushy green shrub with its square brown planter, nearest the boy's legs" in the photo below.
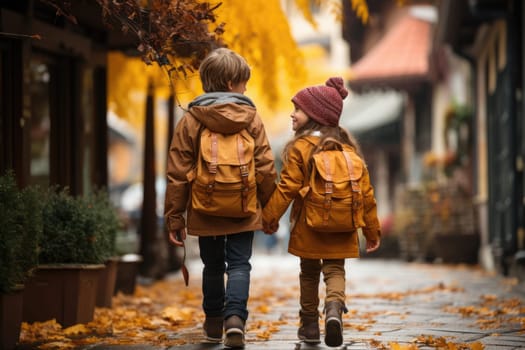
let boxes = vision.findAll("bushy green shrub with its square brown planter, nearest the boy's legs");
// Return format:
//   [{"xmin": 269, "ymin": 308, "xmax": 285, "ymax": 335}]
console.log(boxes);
[{"xmin": 23, "ymin": 188, "xmax": 115, "ymax": 327}]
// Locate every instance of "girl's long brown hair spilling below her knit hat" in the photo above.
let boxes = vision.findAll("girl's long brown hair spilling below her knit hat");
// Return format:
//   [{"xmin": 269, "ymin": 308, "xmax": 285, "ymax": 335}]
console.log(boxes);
[{"xmin": 281, "ymin": 118, "xmax": 364, "ymax": 163}]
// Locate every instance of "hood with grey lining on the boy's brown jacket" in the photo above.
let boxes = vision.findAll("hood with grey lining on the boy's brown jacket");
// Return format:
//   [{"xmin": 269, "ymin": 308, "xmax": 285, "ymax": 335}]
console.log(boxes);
[{"xmin": 189, "ymin": 92, "xmax": 257, "ymax": 134}]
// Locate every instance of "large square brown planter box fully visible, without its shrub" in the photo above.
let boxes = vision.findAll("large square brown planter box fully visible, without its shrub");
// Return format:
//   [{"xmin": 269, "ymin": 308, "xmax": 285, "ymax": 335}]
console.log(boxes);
[{"xmin": 23, "ymin": 264, "xmax": 104, "ymax": 327}]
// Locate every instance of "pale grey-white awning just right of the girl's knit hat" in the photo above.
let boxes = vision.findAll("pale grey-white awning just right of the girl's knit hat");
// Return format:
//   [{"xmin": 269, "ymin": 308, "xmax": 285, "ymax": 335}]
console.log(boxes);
[{"xmin": 340, "ymin": 90, "xmax": 403, "ymax": 142}]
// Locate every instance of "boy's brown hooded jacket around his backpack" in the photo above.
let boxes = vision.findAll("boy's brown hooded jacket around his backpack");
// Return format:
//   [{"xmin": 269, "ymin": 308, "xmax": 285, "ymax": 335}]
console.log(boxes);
[{"xmin": 164, "ymin": 93, "xmax": 277, "ymax": 236}]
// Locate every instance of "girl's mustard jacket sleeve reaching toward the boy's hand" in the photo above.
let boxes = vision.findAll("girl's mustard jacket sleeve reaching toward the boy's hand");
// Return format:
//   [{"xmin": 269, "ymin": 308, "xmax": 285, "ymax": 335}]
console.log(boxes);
[{"xmin": 263, "ymin": 145, "xmax": 304, "ymax": 226}]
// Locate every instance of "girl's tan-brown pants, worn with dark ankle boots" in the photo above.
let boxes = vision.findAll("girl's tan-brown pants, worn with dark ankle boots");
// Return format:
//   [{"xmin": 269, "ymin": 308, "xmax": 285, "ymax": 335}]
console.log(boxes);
[{"xmin": 299, "ymin": 258, "xmax": 346, "ymax": 317}]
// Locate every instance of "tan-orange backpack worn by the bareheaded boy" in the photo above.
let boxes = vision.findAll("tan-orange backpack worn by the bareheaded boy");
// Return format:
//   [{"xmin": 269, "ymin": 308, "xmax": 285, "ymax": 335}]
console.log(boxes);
[{"xmin": 191, "ymin": 128, "xmax": 257, "ymax": 218}]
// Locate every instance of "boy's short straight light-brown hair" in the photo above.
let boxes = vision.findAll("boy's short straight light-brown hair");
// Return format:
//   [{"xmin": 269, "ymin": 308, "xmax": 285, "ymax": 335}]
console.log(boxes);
[{"xmin": 199, "ymin": 47, "xmax": 251, "ymax": 92}]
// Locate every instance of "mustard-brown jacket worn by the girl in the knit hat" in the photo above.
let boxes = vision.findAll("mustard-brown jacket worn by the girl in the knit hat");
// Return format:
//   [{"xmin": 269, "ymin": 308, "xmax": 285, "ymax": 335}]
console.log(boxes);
[{"xmin": 263, "ymin": 135, "xmax": 381, "ymax": 259}]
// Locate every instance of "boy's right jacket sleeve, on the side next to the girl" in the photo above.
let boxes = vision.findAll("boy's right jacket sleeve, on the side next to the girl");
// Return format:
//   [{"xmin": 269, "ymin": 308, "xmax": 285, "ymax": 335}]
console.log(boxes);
[{"xmin": 252, "ymin": 114, "xmax": 277, "ymax": 207}]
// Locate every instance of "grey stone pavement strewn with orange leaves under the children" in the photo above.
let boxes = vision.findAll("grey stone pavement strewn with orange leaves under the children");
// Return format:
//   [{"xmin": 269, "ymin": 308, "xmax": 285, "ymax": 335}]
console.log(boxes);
[{"xmin": 79, "ymin": 254, "xmax": 525, "ymax": 350}]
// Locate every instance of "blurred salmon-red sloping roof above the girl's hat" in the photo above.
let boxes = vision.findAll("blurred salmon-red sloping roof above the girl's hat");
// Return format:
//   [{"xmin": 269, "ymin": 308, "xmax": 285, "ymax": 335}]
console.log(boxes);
[{"xmin": 348, "ymin": 15, "xmax": 431, "ymax": 89}]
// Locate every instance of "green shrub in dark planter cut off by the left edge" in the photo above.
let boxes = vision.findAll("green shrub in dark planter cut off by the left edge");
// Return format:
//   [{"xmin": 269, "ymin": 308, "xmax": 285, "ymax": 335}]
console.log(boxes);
[{"xmin": 0, "ymin": 171, "xmax": 42, "ymax": 349}]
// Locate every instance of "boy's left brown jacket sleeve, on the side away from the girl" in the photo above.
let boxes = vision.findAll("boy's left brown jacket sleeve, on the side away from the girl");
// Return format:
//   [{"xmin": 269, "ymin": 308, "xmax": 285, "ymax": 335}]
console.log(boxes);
[{"xmin": 164, "ymin": 115, "xmax": 196, "ymax": 231}]
